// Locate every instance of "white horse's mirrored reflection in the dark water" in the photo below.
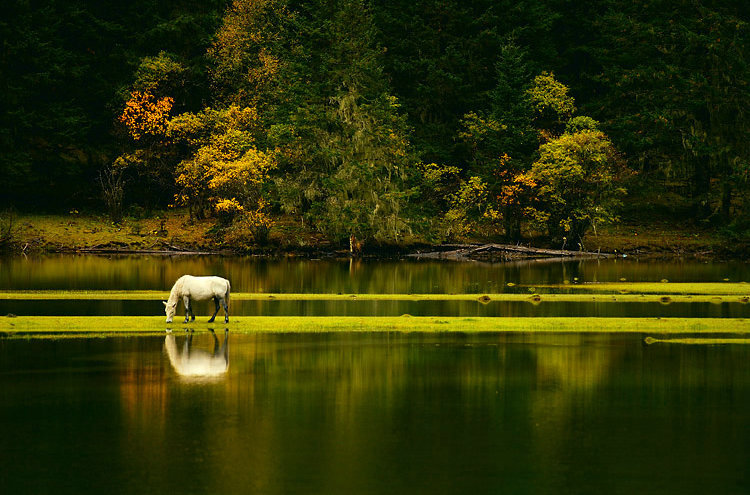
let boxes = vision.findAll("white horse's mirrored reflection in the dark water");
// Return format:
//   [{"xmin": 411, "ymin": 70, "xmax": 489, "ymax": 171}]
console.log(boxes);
[{"xmin": 164, "ymin": 329, "xmax": 229, "ymax": 378}]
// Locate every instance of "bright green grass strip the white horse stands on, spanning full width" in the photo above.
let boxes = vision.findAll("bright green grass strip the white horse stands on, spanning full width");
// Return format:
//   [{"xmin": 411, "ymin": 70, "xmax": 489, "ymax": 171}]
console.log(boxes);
[{"xmin": 0, "ymin": 315, "xmax": 750, "ymax": 335}]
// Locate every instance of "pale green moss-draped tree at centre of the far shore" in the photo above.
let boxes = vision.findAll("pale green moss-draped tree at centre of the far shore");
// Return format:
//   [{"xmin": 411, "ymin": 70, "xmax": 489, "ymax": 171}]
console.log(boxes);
[{"xmin": 313, "ymin": 91, "xmax": 412, "ymax": 242}]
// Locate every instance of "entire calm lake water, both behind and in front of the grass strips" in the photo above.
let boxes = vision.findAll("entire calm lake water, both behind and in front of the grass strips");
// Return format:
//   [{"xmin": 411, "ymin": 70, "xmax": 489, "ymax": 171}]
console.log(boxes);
[{"xmin": 0, "ymin": 256, "xmax": 750, "ymax": 495}]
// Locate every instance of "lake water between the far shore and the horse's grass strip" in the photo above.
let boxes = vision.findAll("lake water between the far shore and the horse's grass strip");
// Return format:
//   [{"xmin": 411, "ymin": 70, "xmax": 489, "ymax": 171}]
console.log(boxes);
[{"xmin": 0, "ymin": 255, "xmax": 750, "ymax": 318}]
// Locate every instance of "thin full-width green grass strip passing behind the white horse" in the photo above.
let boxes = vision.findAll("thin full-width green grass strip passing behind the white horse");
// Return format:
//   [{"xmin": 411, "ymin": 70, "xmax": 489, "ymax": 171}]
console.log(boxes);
[{"xmin": 0, "ymin": 285, "xmax": 750, "ymax": 304}]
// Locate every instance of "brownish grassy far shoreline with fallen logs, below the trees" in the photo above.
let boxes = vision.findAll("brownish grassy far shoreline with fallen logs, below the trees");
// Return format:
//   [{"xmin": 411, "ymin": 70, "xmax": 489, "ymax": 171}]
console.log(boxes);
[{"xmin": 5, "ymin": 212, "xmax": 750, "ymax": 263}]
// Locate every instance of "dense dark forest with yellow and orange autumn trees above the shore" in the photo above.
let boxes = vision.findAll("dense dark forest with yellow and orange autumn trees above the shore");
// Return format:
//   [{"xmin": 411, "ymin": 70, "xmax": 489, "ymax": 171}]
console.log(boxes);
[{"xmin": 0, "ymin": 0, "xmax": 750, "ymax": 245}]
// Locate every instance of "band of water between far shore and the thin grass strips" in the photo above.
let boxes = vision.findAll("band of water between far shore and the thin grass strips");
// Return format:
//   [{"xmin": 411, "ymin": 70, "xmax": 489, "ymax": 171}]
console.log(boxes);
[{"xmin": 0, "ymin": 255, "xmax": 748, "ymax": 293}]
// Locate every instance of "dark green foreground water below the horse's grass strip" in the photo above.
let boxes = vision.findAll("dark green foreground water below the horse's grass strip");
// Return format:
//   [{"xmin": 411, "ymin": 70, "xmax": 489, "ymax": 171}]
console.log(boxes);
[{"xmin": 0, "ymin": 334, "xmax": 750, "ymax": 494}]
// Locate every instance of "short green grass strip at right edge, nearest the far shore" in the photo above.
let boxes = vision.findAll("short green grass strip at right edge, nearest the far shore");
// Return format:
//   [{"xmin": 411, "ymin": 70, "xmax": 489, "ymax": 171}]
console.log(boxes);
[{"xmin": 532, "ymin": 282, "xmax": 750, "ymax": 296}]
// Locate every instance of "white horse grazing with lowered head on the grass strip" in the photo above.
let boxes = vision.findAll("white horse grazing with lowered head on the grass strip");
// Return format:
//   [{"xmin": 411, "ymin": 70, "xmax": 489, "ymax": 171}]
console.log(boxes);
[{"xmin": 162, "ymin": 275, "xmax": 230, "ymax": 323}]
